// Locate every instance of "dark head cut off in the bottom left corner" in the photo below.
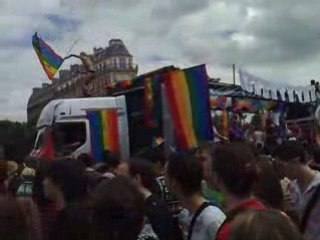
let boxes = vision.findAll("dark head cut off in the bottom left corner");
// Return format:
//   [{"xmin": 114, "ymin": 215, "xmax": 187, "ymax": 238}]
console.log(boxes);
[{"xmin": 0, "ymin": 197, "xmax": 31, "ymax": 240}]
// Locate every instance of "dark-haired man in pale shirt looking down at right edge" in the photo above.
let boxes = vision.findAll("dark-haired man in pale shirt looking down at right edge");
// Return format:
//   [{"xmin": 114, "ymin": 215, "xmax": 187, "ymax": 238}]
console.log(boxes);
[{"xmin": 275, "ymin": 141, "xmax": 320, "ymax": 240}]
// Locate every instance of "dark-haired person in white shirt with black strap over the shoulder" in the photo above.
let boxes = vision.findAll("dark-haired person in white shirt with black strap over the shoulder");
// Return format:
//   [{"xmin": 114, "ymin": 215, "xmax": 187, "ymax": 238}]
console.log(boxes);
[{"xmin": 166, "ymin": 154, "xmax": 226, "ymax": 240}]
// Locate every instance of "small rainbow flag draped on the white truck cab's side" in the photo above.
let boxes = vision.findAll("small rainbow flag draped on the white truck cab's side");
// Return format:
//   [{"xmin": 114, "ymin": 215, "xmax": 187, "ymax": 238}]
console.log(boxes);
[{"xmin": 87, "ymin": 109, "xmax": 120, "ymax": 161}]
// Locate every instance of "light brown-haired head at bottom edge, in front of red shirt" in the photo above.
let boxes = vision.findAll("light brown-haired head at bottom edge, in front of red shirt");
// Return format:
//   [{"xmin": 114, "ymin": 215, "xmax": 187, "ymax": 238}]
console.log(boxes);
[{"xmin": 229, "ymin": 210, "xmax": 303, "ymax": 240}]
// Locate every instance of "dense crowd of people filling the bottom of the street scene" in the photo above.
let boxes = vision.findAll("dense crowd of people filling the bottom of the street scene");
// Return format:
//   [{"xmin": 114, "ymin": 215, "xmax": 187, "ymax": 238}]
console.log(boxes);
[{"xmin": 0, "ymin": 137, "xmax": 320, "ymax": 240}]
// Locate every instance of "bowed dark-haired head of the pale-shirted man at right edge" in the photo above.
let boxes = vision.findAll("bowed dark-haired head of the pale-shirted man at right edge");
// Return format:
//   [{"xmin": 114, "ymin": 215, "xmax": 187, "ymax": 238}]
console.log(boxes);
[{"xmin": 274, "ymin": 141, "xmax": 308, "ymax": 180}]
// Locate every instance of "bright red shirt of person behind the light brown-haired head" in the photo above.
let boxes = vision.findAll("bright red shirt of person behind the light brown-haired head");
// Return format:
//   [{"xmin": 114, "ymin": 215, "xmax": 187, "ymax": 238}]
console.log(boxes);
[{"xmin": 216, "ymin": 199, "xmax": 266, "ymax": 240}]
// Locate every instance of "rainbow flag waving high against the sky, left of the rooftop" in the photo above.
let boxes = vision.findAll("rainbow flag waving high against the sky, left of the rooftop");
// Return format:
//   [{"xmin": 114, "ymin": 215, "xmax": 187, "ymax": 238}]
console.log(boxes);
[{"xmin": 32, "ymin": 33, "xmax": 64, "ymax": 80}]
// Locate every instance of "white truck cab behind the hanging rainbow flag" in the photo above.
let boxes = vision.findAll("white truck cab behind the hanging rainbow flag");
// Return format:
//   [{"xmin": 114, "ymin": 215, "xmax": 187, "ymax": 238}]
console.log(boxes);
[{"xmin": 30, "ymin": 96, "xmax": 129, "ymax": 159}]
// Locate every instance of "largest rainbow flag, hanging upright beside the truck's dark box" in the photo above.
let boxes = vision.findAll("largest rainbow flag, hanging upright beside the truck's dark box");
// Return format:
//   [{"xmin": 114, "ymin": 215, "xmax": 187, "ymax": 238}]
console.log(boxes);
[{"xmin": 164, "ymin": 65, "xmax": 213, "ymax": 150}]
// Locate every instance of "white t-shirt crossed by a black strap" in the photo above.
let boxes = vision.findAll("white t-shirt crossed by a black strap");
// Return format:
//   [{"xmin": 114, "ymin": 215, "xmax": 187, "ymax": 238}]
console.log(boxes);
[{"xmin": 179, "ymin": 206, "xmax": 226, "ymax": 240}]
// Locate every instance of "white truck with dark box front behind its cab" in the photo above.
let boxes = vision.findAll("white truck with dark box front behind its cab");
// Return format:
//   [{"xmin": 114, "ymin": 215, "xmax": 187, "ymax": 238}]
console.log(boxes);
[{"xmin": 30, "ymin": 66, "xmax": 175, "ymax": 159}]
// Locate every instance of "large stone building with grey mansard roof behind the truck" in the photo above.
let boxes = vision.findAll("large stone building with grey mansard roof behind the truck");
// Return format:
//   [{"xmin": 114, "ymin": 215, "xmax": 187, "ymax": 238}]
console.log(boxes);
[{"xmin": 27, "ymin": 39, "xmax": 138, "ymax": 124}]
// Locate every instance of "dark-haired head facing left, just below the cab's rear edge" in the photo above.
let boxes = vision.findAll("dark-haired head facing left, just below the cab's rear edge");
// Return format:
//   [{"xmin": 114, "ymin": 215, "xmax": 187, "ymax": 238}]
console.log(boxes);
[{"xmin": 128, "ymin": 159, "xmax": 157, "ymax": 192}]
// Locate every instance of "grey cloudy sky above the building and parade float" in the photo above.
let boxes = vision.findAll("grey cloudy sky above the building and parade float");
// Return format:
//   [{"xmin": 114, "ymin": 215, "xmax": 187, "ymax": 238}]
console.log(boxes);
[{"xmin": 0, "ymin": 0, "xmax": 320, "ymax": 121}]
